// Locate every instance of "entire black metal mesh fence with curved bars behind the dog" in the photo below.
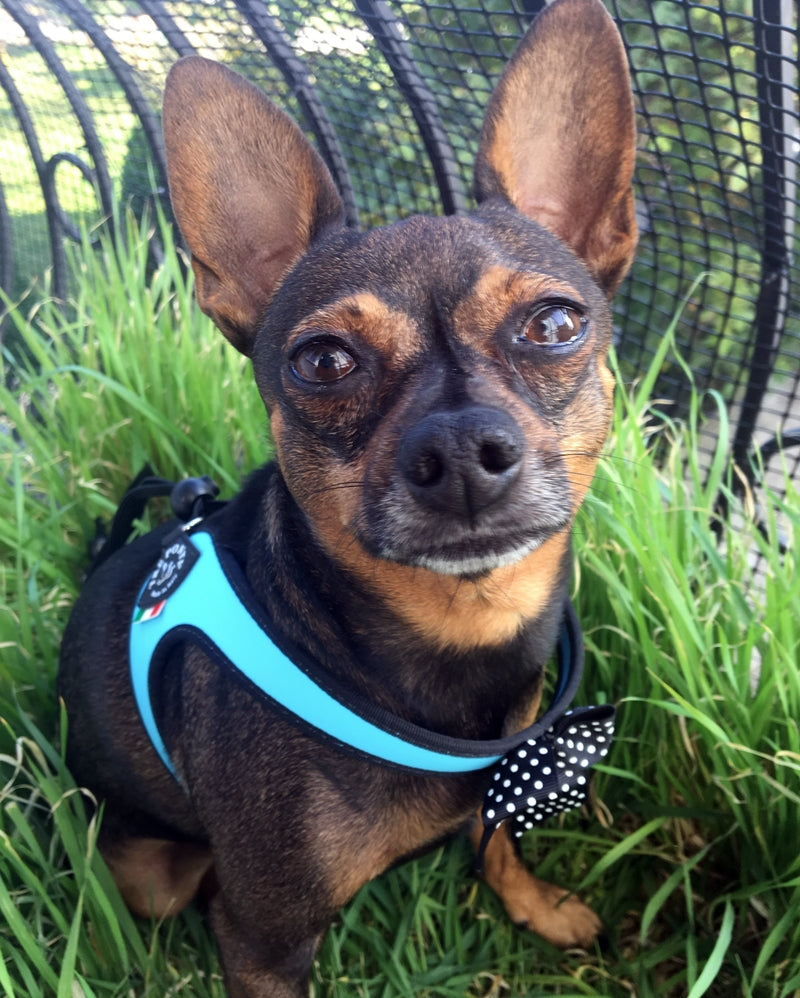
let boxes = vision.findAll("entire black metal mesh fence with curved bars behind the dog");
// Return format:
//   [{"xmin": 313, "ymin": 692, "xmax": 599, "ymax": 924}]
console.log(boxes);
[{"xmin": 0, "ymin": 0, "xmax": 800, "ymax": 498}]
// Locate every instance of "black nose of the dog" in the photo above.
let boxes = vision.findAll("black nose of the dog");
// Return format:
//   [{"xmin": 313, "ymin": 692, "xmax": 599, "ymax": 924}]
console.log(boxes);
[{"xmin": 398, "ymin": 406, "xmax": 525, "ymax": 518}]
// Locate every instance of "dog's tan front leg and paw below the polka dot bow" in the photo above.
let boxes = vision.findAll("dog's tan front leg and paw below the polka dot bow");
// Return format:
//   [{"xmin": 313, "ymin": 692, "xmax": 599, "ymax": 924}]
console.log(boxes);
[{"xmin": 470, "ymin": 817, "xmax": 603, "ymax": 949}]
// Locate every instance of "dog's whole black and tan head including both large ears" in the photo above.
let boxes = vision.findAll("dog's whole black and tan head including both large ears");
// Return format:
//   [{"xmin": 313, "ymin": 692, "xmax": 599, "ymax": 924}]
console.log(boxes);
[{"xmin": 164, "ymin": 0, "xmax": 636, "ymax": 646}]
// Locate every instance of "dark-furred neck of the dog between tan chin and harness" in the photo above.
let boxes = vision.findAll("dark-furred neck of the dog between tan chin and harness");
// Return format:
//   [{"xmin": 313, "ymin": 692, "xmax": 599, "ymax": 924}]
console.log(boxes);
[{"xmin": 220, "ymin": 466, "xmax": 566, "ymax": 738}]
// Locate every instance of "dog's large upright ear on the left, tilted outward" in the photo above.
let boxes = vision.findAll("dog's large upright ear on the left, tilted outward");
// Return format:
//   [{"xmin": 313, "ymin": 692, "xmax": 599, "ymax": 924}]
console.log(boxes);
[{"xmin": 163, "ymin": 56, "xmax": 342, "ymax": 356}]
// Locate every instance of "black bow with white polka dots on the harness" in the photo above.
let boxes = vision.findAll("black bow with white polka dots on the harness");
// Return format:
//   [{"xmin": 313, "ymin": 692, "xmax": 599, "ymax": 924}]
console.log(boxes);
[{"xmin": 482, "ymin": 705, "xmax": 614, "ymax": 838}]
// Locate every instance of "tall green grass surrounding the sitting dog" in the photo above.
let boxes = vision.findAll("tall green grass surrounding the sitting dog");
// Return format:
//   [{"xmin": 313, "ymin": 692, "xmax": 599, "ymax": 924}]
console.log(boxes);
[{"xmin": 0, "ymin": 219, "xmax": 800, "ymax": 998}]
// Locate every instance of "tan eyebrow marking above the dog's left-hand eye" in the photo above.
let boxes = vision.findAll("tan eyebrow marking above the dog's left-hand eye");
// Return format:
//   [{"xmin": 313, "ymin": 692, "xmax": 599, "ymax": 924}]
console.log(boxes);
[{"xmin": 288, "ymin": 291, "xmax": 421, "ymax": 366}]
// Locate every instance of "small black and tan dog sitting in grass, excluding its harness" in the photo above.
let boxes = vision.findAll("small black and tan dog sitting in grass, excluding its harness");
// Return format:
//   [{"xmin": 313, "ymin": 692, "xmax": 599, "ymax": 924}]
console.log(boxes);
[{"xmin": 59, "ymin": 0, "xmax": 635, "ymax": 998}]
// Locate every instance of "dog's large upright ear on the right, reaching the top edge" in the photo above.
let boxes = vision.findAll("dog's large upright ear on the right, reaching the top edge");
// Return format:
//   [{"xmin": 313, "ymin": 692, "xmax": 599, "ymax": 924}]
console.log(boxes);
[{"xmin": 475, "ymin": 0, "xmax": 636, "ymax": 296}]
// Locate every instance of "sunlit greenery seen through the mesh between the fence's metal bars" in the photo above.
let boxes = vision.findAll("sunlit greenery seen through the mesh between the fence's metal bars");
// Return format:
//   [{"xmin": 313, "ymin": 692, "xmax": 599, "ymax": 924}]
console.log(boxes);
[{"xmin": 0, "ymin": 0, "xmax": 800, "ymax": 402}]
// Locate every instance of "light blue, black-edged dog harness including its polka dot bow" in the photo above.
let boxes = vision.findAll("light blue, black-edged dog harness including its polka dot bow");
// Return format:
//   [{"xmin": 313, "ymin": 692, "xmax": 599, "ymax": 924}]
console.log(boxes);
[{"xmin": 115, "ymin": 483, "xmax": 614, "ymax": 862}]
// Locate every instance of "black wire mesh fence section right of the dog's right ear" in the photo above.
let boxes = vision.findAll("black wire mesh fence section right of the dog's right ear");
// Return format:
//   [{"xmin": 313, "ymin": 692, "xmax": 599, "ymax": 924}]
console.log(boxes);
[{"xmin": 616, "ymin": 0, "xmax": 800, "ymax": 492}]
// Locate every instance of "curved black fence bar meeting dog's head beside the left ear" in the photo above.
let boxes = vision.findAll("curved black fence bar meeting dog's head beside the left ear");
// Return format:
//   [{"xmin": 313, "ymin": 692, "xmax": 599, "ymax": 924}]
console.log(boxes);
[{"xmin": 231, "ymin": 0, "xmax": 358, "ymax": 228}]
